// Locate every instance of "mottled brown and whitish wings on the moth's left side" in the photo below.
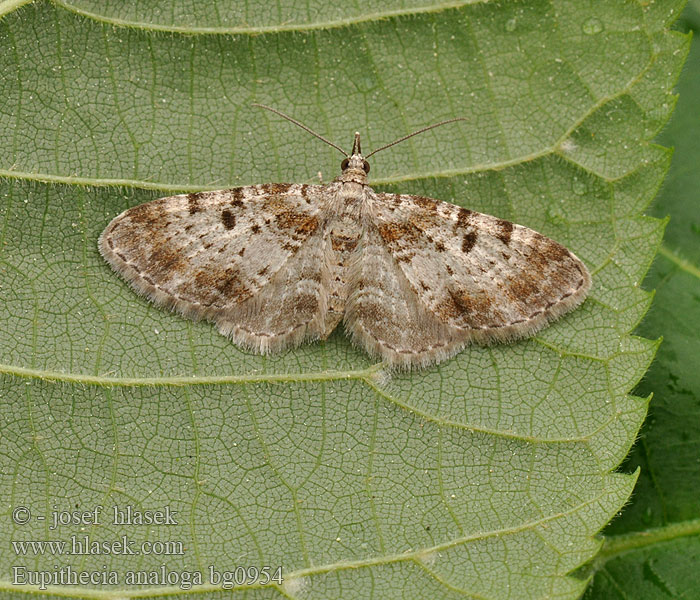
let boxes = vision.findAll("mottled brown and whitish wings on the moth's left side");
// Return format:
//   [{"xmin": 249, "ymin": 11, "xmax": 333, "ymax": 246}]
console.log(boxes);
[{"xmin": 99, "ymin": 184, "xmax": 325, "ymax": 351}]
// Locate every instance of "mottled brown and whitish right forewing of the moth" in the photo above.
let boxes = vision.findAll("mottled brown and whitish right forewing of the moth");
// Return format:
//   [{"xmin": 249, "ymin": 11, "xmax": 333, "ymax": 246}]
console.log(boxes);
[{"xmin": 372, "ymin": 194, "xmax": 591, "ymax": 342}]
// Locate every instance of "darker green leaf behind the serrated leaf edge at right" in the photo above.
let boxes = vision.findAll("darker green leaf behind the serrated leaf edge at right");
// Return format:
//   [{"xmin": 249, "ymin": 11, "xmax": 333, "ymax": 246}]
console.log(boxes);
[{"xmin": 587, "ymin": 2, "xmax": 700, "ymax": 600}]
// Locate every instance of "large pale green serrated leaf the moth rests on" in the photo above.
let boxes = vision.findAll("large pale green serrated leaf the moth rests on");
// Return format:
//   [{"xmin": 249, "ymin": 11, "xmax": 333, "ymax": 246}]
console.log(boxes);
[{"xmin": 0, "ymin": 1, "xmax": 688, "ymax": 598}]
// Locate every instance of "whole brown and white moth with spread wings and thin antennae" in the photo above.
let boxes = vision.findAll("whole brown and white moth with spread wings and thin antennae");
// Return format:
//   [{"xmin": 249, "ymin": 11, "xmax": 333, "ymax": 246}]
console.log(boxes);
[{"xmin": 99, "ymin": 107, "xmax": 591, "ymax": 368}]
